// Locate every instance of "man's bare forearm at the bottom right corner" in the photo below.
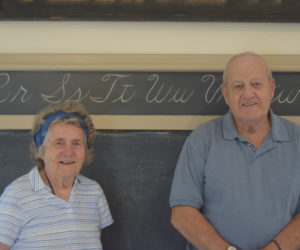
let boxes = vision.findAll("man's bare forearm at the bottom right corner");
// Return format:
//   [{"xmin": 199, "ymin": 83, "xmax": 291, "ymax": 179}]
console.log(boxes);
[{"xmin": 262, "ymin": 213, "xmax": 300, "ymax": 250}]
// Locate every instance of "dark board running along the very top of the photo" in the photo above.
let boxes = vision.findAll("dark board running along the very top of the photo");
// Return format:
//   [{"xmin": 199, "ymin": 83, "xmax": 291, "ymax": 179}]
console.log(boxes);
[{"xmin": 0, "ymin": 0, "xmax": 300, "ymax": 22}]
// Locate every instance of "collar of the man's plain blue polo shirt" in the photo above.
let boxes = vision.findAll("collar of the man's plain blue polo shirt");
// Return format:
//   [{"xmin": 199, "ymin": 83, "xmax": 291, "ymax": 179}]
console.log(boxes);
[{"xmin": 222, "ymin": 110, "xmax": 291, "ymax": 141}]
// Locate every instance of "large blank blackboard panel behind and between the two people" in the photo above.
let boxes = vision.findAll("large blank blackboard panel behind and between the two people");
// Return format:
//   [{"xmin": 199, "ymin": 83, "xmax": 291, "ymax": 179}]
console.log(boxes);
[{"xmin": 0, "ymin": 130, "xmax": 190, "ymax": 250}]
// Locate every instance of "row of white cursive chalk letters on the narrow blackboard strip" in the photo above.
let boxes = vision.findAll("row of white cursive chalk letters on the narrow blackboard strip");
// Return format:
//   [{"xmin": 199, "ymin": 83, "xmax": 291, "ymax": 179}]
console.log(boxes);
[{"xmin": 0, "ymin": 72, "xmax": 300, "ymax": 114}]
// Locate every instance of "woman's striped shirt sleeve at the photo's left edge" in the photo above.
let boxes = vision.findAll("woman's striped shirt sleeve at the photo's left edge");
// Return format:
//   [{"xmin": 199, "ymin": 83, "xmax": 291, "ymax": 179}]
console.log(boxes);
[{"xmin": 0, "ymin": 186, "xmax": 22, "ymax": 246}]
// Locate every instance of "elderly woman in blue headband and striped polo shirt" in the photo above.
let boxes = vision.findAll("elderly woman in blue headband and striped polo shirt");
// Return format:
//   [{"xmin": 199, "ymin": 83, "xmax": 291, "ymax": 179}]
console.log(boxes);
[{"xmin": 0, "ymin": 102, "xmax": 113, "ymax": 250}]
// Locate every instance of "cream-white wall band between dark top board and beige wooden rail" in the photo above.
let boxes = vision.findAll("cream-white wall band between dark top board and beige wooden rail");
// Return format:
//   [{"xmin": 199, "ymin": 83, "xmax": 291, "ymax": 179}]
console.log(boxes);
[{"xmin": 0, "ymin": 21, "xmax": 300, "ymax": 55}]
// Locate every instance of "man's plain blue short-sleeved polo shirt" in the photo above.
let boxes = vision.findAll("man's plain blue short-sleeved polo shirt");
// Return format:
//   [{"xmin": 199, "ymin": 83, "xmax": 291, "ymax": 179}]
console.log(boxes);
[{"xmin": 170, "ymin": 111, "xmax": 300, "ymax": 250}]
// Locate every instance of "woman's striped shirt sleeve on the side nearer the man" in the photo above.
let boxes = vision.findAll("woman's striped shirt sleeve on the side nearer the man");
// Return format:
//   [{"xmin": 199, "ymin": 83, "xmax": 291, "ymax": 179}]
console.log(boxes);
[{"xmin": 98, "ymin": 186, "xmax": 113, "ymax": 230}]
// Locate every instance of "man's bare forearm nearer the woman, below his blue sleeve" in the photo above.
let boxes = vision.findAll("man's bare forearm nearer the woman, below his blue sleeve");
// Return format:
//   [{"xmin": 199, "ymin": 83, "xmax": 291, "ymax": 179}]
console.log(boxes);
[{"xmin": 171, "ymin": 206, "xmax": 230, "ymax": 250}]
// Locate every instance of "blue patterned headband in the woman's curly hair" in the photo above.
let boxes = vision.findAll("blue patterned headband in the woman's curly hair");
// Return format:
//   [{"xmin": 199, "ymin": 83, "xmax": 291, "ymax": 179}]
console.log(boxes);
[{"xmin": 34, "ymin": 110, "xmax": 89, "ymax": 148}]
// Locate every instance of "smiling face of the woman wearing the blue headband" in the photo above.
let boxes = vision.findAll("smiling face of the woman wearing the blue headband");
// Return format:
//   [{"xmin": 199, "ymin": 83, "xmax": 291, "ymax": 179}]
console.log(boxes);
[{"xmin": 41, "ymin": 122, "xmax": 86, "ymax": 181}]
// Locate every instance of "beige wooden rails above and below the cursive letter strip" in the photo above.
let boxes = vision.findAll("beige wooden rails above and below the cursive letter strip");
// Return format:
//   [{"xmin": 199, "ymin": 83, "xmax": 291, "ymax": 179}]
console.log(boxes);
[{"xmin": 0, "ymin": 54, "xmax": 300, "ymax": 130}]
